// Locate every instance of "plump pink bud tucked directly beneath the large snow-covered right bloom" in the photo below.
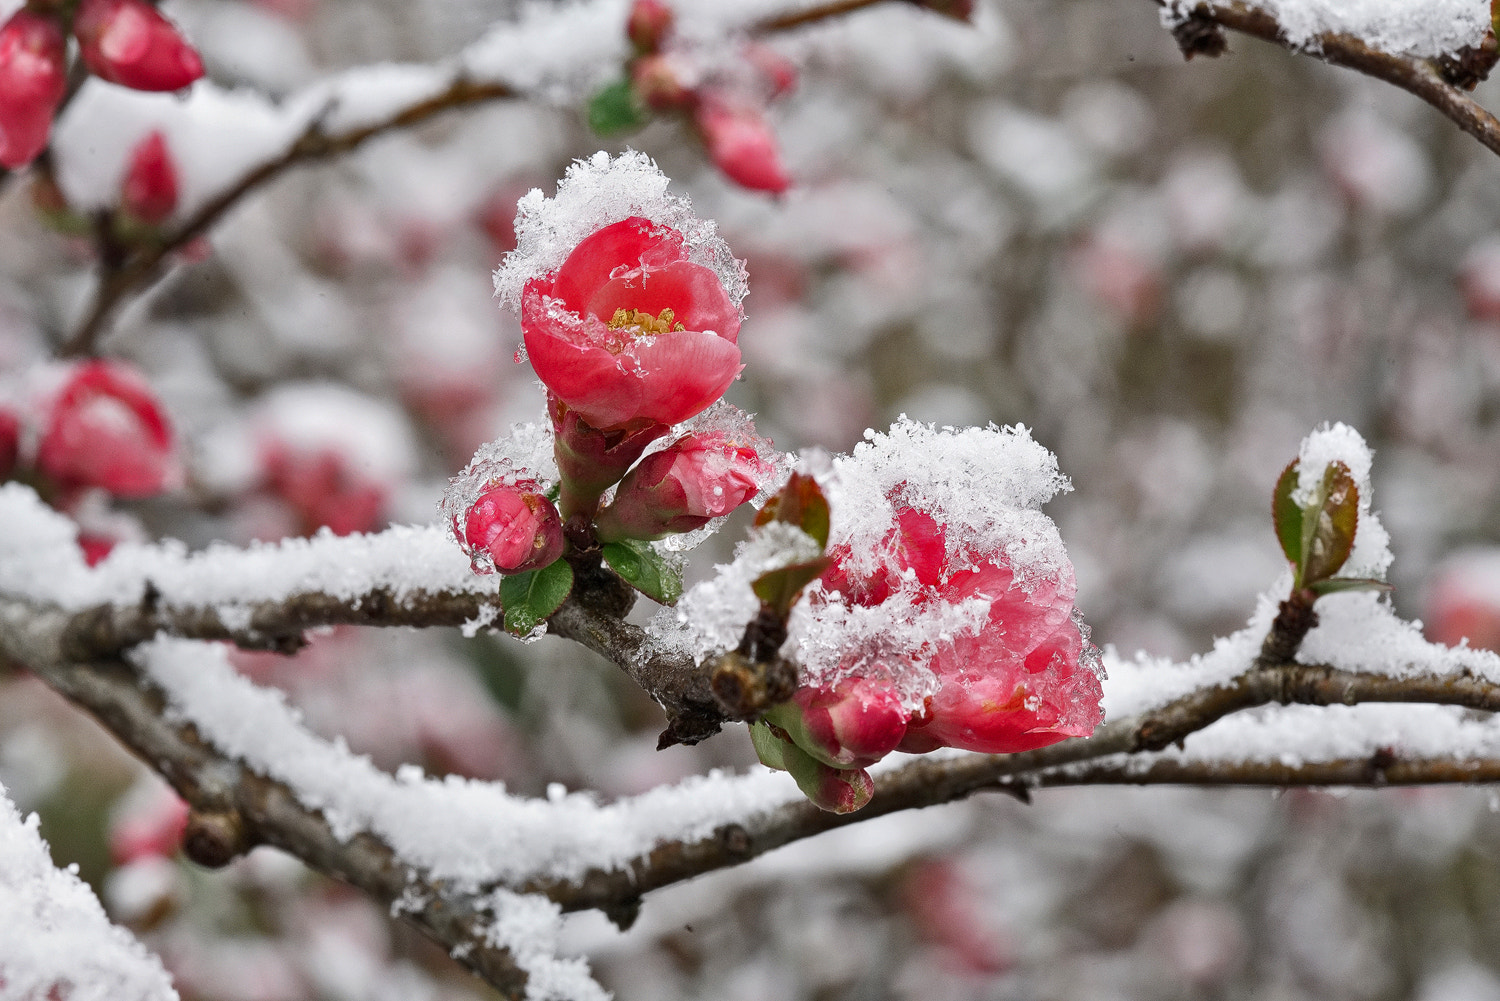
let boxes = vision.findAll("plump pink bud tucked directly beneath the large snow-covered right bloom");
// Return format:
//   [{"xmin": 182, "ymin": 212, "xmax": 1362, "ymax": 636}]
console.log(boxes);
[{"xmin": 765, "ymin": 678, "xmax": 908, "ymax": 768}]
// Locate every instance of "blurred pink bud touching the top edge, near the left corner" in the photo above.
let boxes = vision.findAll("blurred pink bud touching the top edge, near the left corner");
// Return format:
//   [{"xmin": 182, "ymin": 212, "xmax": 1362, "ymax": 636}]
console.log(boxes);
[{"xmin": 74, "ymin": 0, "xmax": 203, "ymax": 90}]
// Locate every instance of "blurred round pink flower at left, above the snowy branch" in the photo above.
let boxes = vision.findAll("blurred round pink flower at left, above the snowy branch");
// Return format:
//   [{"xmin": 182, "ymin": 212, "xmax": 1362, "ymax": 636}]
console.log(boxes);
[{"xmin": 36, "ymin": 360, "xmax": 177, "ymax": 497}]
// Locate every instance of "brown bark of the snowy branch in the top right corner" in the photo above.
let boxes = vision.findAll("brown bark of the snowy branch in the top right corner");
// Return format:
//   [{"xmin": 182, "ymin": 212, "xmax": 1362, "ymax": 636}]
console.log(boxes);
[{"xmin": 1154, "ymin": 0, "xmax": 1500, "ymax": 155}]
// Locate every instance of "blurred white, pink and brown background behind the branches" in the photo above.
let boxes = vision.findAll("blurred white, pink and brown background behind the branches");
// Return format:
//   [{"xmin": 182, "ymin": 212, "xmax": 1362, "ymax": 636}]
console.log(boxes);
[{"xmin": 0, "ymin": 0, "xmax": 1500, "ymax": 1001}]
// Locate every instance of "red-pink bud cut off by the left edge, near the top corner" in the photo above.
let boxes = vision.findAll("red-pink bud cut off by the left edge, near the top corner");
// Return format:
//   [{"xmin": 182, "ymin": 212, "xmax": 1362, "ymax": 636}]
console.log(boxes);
[{"xmin": 0, "ymin": 8, "xmax": 68, "ymax": 170}]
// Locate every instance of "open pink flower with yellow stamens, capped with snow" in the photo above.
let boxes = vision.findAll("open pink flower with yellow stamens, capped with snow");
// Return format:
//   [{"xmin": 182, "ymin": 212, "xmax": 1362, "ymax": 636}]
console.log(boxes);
[{"xmin": 521, "ymin": 216, "xmax": 743, "ymax": 431}]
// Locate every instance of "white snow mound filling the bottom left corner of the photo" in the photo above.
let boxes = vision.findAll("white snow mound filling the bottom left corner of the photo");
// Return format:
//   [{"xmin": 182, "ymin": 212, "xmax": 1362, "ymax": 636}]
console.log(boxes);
[{"xmin": 0, "ymin": 786, "xmax": 177, "ymax": 1001}]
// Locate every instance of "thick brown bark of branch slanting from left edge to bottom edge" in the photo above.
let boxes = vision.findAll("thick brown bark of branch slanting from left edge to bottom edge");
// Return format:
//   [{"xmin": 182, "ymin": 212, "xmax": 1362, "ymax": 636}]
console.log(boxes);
[{"xmin": 0, "ymin": 599, "xmax": 527, "ymax": 998}]
